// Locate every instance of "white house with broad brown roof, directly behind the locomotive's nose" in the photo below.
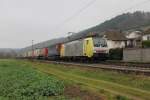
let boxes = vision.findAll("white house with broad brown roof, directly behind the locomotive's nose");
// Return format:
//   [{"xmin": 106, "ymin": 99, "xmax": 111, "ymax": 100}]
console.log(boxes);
[{"xmin": 103, "ymin": 30, "xmax": 127, "ymax": 49}]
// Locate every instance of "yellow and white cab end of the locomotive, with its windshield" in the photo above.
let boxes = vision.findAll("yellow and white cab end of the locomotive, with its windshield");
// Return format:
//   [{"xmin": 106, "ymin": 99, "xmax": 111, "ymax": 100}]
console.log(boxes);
[{"xmin": 84, "ymin": 37, "xmax": 109, "ymax": 59}]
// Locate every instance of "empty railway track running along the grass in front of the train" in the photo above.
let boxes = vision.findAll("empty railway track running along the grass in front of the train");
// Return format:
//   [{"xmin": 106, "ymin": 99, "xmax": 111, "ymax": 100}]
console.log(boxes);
[{"xmin": 36, "ymin": 60, "xmax": 150, "ymax": 76}]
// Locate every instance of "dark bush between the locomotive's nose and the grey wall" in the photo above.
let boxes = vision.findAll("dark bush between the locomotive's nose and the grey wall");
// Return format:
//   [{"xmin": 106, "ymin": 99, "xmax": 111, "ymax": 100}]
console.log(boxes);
[{"xmin": 109, "ymin": 48, "xmax": 123, "ymax": 60}]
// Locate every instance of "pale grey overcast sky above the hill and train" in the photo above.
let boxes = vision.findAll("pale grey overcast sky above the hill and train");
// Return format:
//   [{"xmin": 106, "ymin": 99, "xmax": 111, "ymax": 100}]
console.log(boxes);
[{"xmin": 0, "ymin": 0, "xmax": 150, "ymax": 48}]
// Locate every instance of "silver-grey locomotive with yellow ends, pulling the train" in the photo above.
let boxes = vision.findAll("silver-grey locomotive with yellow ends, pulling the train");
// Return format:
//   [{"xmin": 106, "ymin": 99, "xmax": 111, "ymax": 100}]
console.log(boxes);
[{"xmin": 60, "ymin": 37, "xmax": 109, "ymax": 60}]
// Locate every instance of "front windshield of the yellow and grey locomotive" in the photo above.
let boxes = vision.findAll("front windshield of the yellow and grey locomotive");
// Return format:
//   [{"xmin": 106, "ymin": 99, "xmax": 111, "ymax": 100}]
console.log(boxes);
[{"xmin": 93, "ymin": 37, "xmax": 107, "ymax": 47}]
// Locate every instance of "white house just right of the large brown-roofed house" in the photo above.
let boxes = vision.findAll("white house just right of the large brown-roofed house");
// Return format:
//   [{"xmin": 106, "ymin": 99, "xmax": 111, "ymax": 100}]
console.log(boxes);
[{"xmin": 126, "ymin": 31, "xmax": 143, "ymax": 48}]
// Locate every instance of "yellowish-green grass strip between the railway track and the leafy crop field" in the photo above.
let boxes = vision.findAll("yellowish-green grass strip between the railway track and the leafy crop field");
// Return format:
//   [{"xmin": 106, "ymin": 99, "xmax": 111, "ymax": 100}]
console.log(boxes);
[{"xmin": 29, "ymin": 62, "xmax": 150, "ymax": 100}]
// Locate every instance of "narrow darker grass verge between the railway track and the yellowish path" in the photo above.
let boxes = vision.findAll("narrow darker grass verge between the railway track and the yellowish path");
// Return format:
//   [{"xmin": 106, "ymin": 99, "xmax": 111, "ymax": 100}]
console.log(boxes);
[{"xmin": 55, "ymin": 66, "xmax": 150, "ymax": 91}]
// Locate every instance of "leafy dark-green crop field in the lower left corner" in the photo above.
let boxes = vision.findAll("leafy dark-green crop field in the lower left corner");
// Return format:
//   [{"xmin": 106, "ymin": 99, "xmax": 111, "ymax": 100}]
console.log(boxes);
[{"xmin": 0, "ymin": 60, "xmax": 64, "ymax": 100}]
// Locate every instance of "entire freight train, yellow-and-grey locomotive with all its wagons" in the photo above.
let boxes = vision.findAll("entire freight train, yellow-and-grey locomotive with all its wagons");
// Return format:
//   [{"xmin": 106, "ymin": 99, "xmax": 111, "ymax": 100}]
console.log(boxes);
[{"xmin": 21, "ymin": 37, "xmax": 109, "ymax": 60}]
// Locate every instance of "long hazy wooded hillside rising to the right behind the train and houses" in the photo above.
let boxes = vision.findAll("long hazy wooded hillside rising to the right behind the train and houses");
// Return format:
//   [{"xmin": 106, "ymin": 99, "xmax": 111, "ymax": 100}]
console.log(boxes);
[{"xmin": 23, "ymin": 11, "xmax": 150, "ymax": 51}]
